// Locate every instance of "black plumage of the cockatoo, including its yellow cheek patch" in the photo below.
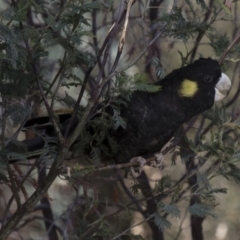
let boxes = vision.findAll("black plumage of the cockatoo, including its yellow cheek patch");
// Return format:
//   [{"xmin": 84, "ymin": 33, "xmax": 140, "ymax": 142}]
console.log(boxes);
[{"xmin": 11, "ymin": 58, "xmax": 231, "ymax": 162}]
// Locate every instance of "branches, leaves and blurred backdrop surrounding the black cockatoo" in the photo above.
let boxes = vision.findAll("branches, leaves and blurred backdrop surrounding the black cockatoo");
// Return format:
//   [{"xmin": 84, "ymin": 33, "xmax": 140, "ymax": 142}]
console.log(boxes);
[{"xmin": 0, "ymin": 0, "xmax": 240, "ymax": 240}]
